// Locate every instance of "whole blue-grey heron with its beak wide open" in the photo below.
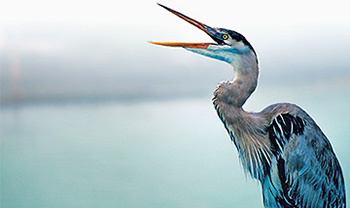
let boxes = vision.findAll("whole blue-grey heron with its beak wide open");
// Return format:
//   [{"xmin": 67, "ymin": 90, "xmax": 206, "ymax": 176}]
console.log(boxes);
[{"xmin": 149, "ymin": 4, "xmax": 346, "ymax": 208}]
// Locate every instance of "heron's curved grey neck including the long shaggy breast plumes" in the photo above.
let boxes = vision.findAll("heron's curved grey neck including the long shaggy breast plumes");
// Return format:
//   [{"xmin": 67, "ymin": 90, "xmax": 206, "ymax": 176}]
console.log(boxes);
[{"xmin": 213, "ymin": 51, "xmax": 271, "ymax": 180}]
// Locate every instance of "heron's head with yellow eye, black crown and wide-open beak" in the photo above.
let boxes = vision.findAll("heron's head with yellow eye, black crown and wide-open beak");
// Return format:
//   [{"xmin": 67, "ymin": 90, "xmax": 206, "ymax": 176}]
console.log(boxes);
[{"xmin": 150, "ymin": 4, "xmax": 256, "ymax": 67}]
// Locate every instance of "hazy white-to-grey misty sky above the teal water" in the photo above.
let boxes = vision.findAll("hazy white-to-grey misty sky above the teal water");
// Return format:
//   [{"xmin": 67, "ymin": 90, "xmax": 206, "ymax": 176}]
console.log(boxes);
[{"xmin": 0, "ymin": 1, "xmax": 350, "ymax": 104}]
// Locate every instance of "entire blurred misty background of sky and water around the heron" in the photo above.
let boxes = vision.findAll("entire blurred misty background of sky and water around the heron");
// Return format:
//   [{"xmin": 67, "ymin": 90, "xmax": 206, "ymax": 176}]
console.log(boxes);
[{"xmin": 0, "ymin": 0, "xmax": 350, "ymax": 207}]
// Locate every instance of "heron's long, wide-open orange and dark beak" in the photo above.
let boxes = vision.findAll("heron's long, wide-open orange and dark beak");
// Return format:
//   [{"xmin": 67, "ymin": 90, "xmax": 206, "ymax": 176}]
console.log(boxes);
[{"xmin": 149, "ymin": 3, "xmax": 224, "ymax": 49}]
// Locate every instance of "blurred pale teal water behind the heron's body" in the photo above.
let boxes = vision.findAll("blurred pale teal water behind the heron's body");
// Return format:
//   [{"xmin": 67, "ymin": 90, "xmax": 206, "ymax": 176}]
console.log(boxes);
[{"xmin": 1, "ymin": 89, "xmax": 350, "ymax": 208}]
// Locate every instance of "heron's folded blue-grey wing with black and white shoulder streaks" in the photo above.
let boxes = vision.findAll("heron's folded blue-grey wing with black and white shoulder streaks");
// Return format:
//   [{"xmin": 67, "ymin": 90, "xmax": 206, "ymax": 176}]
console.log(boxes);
[{"xmin": 264, "ymin": 113, "xmax": 345, "ymax": 207}]
